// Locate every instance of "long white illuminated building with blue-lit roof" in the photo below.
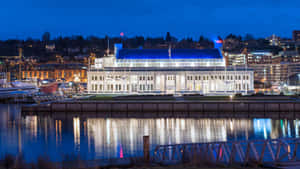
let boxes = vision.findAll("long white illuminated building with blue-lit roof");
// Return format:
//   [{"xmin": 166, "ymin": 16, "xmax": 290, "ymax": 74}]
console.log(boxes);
[{"xmin": 87, "ymin": 44, "xmax": 254, "ymax": 95}]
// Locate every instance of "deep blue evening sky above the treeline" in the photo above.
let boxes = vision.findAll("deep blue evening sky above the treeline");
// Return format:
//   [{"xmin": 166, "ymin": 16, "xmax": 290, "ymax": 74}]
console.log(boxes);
[{"xmin": 0, "ymin": 0, "xmax": 300, "ymax": 39}]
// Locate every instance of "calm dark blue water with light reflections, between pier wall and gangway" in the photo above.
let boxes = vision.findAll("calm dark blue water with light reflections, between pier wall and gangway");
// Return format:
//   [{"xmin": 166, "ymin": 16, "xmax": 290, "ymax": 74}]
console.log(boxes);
[{"xmin": 0, "ymin": 104, "xmax": 300, "ymax": 161}]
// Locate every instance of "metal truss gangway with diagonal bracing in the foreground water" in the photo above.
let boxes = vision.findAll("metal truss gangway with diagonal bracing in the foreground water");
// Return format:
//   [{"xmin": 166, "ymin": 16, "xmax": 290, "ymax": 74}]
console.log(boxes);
[{"xmin": 153, "ymin": 139, "xmax": 300, "ymax": 167}]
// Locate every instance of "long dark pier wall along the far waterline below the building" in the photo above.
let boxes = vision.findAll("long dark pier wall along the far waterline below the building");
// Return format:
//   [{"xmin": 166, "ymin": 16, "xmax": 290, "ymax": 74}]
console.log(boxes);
[{"xmin": 22, "ymin": 100, "xmax": 300, "ymax": 119}]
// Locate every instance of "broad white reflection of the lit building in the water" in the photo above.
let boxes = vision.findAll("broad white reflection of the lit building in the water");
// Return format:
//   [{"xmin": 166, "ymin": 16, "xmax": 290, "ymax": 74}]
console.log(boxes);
[{"xmin": 86, "ymin": 118, "xmax": 253, "ymax": 157}]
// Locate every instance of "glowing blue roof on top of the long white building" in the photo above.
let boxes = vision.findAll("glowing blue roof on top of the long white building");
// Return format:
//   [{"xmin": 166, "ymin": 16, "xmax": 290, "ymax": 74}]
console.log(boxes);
[{"xmin": 116, "ymin": 49, "xmax": 223, "ymax": 59}]
